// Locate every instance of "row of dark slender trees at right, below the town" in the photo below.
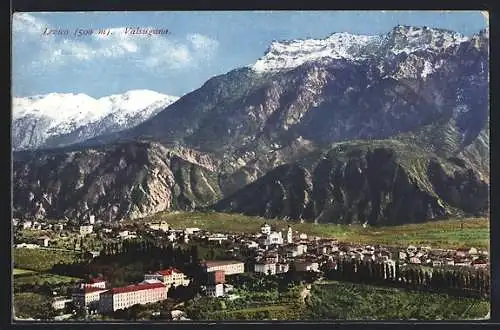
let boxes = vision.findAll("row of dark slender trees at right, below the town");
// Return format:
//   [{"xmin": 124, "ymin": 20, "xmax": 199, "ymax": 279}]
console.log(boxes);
[{"xmin": 324, "ymin": 259, "xmax": 490, "ymax": 297}]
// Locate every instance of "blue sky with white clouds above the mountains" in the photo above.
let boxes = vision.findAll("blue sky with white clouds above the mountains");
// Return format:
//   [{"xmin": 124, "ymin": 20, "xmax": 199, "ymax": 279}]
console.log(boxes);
[{"xmin": 12, "ymin": 11, "xmax": 487, "ymax": 98}]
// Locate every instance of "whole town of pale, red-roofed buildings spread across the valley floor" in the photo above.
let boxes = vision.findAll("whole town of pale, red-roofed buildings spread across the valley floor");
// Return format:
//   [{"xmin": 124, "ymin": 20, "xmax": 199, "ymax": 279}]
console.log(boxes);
[{"xmin": 13, "ymin": 216, "xmax": 489, "ymax": 319}]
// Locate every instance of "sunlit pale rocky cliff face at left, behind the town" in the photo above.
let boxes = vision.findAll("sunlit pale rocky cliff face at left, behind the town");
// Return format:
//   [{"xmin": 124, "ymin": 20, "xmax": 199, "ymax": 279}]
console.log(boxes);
[{"xmin": 13, "ymin": 143, "xmax": 221, "ymax": 220}]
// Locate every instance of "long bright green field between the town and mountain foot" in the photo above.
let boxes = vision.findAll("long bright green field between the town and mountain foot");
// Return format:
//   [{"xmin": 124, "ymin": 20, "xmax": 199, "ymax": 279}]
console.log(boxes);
[{"xmin": 141, "ymin": 212, "xmax": 490, "ymax": 248}]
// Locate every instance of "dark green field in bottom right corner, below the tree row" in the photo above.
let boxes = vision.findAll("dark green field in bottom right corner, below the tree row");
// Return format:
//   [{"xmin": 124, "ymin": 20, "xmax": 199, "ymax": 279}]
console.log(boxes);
[{"xmin": 304, "ymin": 282, "xmax": 490, "ymax": 320}]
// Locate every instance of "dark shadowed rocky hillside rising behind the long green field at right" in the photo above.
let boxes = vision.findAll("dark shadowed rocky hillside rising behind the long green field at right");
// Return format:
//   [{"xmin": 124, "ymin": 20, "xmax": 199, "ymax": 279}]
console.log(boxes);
[{"xmin": 214, "ymin": 141, "xmax": 489, "ymax": 225}]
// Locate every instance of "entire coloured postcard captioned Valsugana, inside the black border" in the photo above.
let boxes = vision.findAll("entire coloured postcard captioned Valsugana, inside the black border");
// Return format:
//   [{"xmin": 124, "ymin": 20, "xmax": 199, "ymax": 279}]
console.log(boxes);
[{"xmin": 11, "ymin": 11, "xmax": 491, "ymax": 322}]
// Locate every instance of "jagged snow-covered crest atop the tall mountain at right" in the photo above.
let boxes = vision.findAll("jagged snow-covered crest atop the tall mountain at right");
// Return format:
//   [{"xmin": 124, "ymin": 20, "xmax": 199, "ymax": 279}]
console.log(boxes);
[{"xmin": 250, "ymin": 25, "xmax": 468, "ymax": 72}]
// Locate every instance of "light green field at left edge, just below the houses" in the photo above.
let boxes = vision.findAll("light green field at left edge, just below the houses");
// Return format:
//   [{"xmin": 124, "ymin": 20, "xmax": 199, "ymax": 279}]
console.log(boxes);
[{"xmin": 12, "ymin": 248, "xmax": 79, "ymax": 272}]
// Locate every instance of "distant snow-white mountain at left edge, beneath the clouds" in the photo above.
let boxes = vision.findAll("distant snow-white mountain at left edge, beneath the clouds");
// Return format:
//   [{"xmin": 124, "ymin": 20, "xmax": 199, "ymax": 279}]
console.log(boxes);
[{"xmin": 12, "ymin": 90, "xmax": 178, "ymax": 149}]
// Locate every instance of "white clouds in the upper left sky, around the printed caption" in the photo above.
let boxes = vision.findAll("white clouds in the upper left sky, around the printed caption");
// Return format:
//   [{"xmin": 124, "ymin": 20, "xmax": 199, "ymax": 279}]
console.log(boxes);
[{"xmin": 12, "ymin": 13, "xmax": 219, "ymax": 71}]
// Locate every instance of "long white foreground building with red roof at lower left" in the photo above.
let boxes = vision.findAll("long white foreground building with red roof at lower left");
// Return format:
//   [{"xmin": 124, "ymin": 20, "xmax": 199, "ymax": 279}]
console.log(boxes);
[{"xmin": 99, "ymin": 283, "xmax": 167, "ymax": 313}]
